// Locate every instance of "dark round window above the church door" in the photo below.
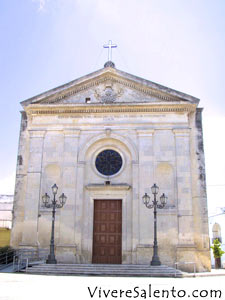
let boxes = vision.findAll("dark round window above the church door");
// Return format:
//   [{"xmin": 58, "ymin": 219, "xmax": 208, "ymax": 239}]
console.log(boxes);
[{"xmin": 95, "ymin": 149, "xmax": 123, "ymax": 176}]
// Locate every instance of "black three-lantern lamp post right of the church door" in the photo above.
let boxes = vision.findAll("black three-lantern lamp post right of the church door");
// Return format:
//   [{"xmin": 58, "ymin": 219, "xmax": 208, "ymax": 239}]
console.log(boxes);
[{"xmin": 142, "ymin": 183, "xmax": 167, "ymax": 266}]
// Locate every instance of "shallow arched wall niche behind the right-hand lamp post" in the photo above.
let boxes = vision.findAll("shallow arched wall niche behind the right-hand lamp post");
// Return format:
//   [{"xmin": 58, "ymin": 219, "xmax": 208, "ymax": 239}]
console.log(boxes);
[{"xmin": 155, "ymin": 162, "xmax": 175, "ymax": 206}]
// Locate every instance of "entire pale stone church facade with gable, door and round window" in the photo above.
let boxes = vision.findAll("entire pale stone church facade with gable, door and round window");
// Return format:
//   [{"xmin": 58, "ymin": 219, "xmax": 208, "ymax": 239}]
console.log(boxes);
[{"xmin": 11, "ymin": 61, "xmax": 210, "ymax": 271}]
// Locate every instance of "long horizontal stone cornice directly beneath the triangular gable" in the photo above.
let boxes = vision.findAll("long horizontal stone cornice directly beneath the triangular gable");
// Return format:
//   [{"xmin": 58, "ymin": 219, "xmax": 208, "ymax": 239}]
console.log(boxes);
[{"xmin": 25, "ymin": 103, "xmax": 196, "ymax": 116}]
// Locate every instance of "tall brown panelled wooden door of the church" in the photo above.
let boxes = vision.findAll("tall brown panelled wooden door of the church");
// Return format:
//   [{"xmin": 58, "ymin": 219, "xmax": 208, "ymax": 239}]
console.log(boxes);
[{"xmin": 92, "ymin": 200, "xmax": 122, "ymax": 264}]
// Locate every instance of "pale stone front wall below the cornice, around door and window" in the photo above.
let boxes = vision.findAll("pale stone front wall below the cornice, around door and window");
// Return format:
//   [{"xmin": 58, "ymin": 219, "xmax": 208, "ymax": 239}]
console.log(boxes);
[{"xmin": 11, "ymin": 99, "xmax": 210, "ymax": 271}]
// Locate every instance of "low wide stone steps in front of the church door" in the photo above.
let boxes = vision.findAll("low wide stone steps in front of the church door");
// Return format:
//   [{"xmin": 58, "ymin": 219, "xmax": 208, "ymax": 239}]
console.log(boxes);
[{"xmin": 24, "ymin": 264, "xmax": 184, "ymax": 277}]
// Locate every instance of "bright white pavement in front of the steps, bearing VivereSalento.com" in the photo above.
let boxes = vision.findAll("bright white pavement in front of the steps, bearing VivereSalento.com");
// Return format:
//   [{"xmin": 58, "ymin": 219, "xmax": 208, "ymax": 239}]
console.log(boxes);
[{"xmin": 0, "ymin": 270, "xmax": 225, "ymax": 300}]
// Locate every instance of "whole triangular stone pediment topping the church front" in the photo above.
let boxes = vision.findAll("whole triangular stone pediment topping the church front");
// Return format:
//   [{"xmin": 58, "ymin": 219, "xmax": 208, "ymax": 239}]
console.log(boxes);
[{"xmin": 21, "ymin": 67, "xmax": 199, "ymax": 107}]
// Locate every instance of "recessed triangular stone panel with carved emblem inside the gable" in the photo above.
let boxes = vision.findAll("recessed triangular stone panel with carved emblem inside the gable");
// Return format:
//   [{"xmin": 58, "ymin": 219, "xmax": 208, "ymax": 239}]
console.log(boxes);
[{"xmin": 35, "ymin": 74, "xmax": 183, "ymax": 104}]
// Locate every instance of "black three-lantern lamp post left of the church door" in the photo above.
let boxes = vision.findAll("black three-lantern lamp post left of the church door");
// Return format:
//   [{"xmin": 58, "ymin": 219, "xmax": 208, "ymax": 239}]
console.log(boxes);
[{"xmin": 42, "ymin": 184, "xmax": 67, "ymax": 264}]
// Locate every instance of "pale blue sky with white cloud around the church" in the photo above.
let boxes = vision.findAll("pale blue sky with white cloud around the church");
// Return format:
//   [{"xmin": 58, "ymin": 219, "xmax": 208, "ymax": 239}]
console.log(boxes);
[{"xmin": 0, "ymin": 0, "xmax": 225, "ymax": 214}]
